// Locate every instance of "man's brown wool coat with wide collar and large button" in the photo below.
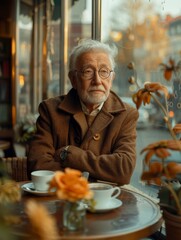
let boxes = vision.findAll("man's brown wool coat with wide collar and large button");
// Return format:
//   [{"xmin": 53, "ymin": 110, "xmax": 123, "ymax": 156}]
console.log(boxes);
[{"xmin": 28, "ymin": 89, "xmax": 138, "ymax": 185}]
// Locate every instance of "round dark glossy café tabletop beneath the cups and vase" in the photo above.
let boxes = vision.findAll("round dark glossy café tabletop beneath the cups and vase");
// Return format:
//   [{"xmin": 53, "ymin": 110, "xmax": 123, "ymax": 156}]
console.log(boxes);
[{"xmin": 10, "ymin": 185, "xmax": 163, "ymax": 240}]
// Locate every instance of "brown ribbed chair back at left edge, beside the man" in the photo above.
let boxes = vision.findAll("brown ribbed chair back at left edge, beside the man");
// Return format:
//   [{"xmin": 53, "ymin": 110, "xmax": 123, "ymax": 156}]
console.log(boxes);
[{"xmin": 1, "ymin": 157, "xmax": 28, "ymax": 182}]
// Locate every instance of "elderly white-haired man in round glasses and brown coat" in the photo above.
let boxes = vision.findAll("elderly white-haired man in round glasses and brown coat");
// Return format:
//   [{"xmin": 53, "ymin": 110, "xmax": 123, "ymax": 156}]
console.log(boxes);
[{"xmin": 28, "ymin": 40, "xmax": 138, "ymax": 185}]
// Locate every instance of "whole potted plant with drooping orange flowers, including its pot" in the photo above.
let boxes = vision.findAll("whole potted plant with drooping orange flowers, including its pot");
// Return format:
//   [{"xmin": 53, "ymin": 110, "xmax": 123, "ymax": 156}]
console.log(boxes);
[{"xmin": 128, "ymin": 59, "xmax": 181, "ymax": 240}]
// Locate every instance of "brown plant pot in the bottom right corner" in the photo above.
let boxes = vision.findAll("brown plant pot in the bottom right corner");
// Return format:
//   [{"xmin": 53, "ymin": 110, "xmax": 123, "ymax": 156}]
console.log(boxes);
[{"xmin": 163, "ymin": 209, "xmax": 181, "ymax": 240}]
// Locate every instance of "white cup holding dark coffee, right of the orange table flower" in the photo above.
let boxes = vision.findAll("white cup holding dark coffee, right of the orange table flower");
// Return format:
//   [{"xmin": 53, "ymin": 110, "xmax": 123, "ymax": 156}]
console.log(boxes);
[{"xmin": 89, "ymin": 183, "xmax": 121, "ymax": 208}]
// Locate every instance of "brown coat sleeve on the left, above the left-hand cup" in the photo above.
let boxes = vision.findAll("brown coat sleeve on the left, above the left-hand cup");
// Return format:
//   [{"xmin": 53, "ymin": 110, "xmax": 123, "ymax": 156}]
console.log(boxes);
[{"xmin": 27, "ymin": 102, "xmax": 61, "ymax": 179}]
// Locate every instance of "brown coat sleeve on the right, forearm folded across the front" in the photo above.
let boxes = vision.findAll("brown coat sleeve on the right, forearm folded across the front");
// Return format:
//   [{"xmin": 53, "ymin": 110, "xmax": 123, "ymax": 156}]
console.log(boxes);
[{"xmin": 53, "ymin": 108, "xmax": 138, "ymax": 185}]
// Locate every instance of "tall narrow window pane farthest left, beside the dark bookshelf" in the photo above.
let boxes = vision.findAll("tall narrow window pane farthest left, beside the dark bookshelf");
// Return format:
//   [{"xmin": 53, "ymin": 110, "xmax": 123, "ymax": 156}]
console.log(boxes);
[{"xmin": 17, "ymin": 2, "xmax": 33, "ymax": 118}]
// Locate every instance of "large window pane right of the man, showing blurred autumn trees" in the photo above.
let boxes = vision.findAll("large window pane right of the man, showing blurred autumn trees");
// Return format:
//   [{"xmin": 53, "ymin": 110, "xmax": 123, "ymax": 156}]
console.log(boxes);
[{"xmin": 102, "ymin": 0, "xmax": 181, "ymax": 126}]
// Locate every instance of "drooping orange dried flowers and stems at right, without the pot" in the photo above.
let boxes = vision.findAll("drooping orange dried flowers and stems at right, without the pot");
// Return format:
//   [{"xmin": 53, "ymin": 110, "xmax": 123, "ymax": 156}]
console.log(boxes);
[{"xmin": 128, "ymin": 59, "xmax": 181, "ymax": 216}]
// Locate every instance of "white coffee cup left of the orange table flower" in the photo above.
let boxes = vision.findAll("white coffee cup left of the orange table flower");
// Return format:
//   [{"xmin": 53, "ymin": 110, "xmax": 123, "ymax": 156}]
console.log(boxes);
[{"xmin": 31, "ymin": 170, "xmax": 54, "ymax": 191}]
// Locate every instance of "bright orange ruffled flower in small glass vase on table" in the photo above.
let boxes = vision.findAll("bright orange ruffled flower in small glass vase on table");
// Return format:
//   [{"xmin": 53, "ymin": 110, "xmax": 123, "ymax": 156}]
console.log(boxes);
[{"xmin": 49, "ymin": 168, "xmax": 93, "ymax": 202}]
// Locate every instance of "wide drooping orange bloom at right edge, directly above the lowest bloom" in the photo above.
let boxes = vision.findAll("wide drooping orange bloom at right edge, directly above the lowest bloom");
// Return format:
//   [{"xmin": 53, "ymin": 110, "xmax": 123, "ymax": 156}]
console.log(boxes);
[{"xmin": 141, "ymin": 140, "xmax": 181, "ymax": 165}]
